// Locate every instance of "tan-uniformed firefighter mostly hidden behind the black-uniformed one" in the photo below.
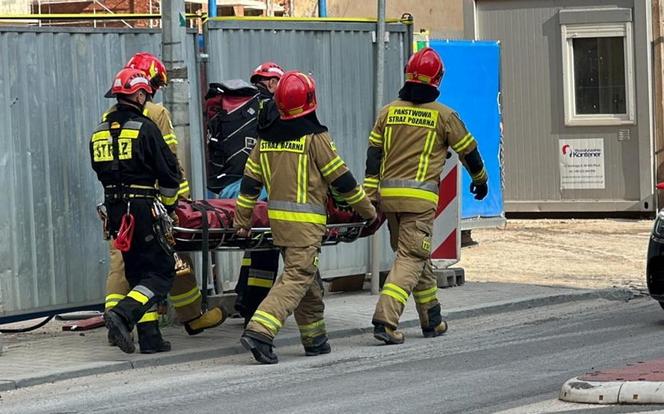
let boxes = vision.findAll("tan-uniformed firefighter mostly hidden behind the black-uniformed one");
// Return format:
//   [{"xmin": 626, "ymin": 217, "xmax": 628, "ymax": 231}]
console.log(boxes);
[{"xmin": 103, "ymin": 52, "xmax": 226, "ymax": 350}]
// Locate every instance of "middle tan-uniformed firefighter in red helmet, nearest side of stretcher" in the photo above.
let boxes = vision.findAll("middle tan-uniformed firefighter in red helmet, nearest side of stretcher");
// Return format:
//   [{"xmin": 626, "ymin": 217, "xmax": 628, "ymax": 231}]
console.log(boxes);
[{"xmin": 235, "ymin": 72, "xmax": 376, "ymax": 364}]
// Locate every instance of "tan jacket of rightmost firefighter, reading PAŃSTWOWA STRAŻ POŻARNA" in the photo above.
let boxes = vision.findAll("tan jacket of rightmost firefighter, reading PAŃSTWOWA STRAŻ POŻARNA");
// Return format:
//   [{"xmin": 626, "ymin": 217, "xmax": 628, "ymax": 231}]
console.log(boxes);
[{"xmin": 364, "ymin": 100, "xmax": 487, "ymax": 213}]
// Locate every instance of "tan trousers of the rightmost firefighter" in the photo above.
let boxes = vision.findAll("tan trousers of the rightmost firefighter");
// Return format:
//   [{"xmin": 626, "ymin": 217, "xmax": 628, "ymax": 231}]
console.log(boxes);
[{"xmin": 372, "ymin": 209, "xmax": 441, "ymax": 329}]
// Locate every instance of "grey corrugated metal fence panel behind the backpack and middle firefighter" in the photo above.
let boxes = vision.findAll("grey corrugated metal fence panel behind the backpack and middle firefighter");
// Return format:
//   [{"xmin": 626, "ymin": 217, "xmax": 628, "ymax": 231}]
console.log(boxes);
[{"xmin": 207, "ymin": 20, "xmax": 409, "ymax": 277}]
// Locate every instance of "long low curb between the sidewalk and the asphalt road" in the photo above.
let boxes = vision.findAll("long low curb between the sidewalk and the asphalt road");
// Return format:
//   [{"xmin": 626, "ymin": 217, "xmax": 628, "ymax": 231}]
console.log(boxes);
[{"xmin": 0, "ymin": 289, "xmax": 634, "ymax": 391}]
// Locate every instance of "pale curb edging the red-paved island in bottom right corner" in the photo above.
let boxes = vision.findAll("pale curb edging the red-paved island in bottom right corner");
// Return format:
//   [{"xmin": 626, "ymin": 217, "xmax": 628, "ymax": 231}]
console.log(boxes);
[{"xmin": 559, "ymin": 378, "xmax": 664, "ymax": 404}]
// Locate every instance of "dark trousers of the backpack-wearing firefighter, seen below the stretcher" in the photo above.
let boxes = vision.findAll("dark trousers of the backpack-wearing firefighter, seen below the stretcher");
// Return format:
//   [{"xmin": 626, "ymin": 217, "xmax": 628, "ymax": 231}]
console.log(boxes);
[{"xmin": 235, "ymin": 249, "xmax": 279, "ymax": 324}]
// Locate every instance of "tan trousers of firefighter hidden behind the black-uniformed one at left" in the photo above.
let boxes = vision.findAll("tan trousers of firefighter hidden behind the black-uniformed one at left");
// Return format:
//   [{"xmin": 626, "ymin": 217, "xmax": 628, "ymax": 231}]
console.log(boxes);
[{"xmin": 106, "ymin": 242, "xmax": 201, "ymax": 323}]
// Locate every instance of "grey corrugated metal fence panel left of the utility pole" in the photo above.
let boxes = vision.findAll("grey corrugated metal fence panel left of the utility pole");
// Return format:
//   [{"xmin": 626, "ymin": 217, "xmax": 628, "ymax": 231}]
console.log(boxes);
[{"xmin": 0, "ymin": 28, "xmax": 205, "ymax": 317}]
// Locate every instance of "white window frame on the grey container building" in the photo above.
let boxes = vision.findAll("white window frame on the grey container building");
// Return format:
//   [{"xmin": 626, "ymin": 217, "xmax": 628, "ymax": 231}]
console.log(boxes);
[{"xmin": 560, "ymin": 22, "xmax": 636, "ymax": 126}]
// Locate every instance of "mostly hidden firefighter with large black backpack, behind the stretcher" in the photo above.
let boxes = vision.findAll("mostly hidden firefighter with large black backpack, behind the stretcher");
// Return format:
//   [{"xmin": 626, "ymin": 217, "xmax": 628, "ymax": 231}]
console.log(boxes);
[{"xmin": 205, "ymin": 62, "xmax": 284, "ymax": 326}]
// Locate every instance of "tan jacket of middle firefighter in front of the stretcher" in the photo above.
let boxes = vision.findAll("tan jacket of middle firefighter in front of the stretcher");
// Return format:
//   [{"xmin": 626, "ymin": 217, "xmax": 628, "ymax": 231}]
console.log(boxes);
[{"xmin": 235, "ymin": 132, "xmax": 376, "ymax": 247}]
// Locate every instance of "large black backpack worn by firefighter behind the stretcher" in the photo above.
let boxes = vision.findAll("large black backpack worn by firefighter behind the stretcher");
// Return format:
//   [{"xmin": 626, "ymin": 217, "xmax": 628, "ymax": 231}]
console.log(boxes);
[{"xmin": 205, "ymin": 80, "xmax": 260, "ymax": 193}]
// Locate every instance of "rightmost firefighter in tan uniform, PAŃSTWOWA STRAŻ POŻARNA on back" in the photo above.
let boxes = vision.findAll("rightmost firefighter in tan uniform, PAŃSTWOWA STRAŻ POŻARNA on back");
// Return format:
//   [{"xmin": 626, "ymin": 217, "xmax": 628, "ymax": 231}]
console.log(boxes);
[{"xmin": 364, "ymin": 48, "xmax": 488, "ymax": 344}]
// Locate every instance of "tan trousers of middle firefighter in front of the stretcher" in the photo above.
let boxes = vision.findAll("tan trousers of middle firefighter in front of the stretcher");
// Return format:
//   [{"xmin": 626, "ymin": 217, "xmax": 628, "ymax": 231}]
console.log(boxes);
[{"xmin": 246, "ymin": 245, "xmax": 327, "ymax": 347}]
